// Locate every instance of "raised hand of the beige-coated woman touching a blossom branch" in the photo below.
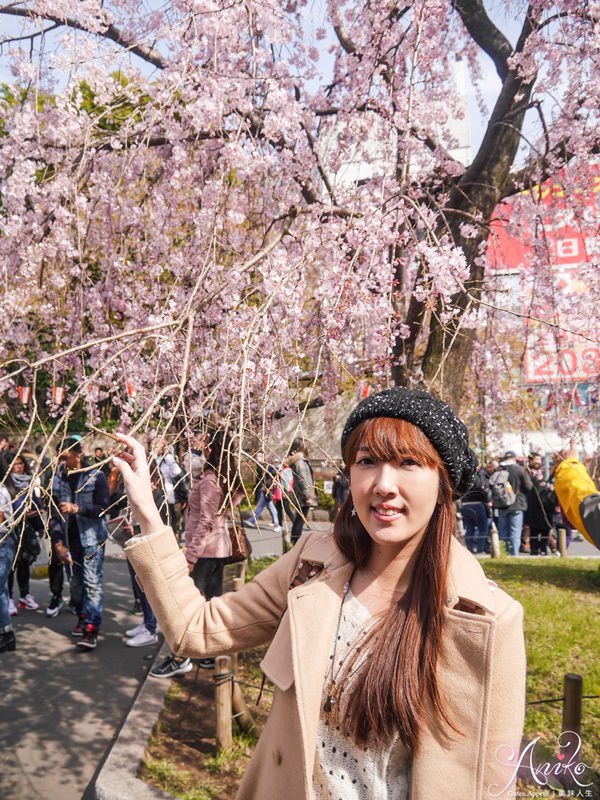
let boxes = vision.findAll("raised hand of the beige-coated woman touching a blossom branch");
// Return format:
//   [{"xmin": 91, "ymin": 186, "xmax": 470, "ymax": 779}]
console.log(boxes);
[{"xmin": 113, "ymin": 433, "xmax": 164, "ymax": 534}]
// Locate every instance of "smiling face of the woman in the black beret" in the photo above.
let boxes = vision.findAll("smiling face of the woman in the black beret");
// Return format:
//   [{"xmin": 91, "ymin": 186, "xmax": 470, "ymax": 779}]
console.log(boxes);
[{"xmin": 350, "ymin": 447, "xmax": 439, "ymax": 546}]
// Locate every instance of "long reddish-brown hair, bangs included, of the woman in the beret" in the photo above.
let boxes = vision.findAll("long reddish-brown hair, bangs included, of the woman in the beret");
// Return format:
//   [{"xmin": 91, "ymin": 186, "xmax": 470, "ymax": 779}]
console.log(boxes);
[{"xmin": 333, "ymin": 417, "xmax": 458, "ymax": 751}]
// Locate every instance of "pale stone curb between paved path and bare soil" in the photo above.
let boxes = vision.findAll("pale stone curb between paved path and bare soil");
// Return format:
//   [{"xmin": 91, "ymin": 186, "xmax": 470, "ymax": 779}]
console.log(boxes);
[{"xmin": 93, "ymin": 642, "xmax": 174, "ymax": 800}]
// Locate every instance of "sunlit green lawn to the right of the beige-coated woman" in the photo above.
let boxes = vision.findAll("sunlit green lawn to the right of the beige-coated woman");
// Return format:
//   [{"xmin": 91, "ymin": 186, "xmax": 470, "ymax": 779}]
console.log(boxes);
[{"xmin": 483, "ymin": 559, "xmax": 600, "ymax": 771}]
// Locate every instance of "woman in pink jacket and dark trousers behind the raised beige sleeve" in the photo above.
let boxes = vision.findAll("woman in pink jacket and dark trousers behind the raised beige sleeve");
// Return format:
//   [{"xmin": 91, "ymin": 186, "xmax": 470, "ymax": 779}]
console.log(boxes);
[{"xmin": 150, "ymin": 430, "xmax": 243, "ymax": 678}]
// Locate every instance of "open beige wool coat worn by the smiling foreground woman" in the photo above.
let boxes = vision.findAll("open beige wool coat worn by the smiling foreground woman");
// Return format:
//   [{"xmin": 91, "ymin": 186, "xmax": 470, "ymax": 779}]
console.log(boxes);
[{"xmin": 125, "ymin": 528, "xmax": 525, "ymax": 800}]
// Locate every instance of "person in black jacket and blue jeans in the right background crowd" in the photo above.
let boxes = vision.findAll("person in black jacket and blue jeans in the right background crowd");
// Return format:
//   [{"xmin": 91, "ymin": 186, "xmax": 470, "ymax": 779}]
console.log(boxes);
[{"xmin": 490, "ymin": 450, "xmax": 533, "ymax": 556}]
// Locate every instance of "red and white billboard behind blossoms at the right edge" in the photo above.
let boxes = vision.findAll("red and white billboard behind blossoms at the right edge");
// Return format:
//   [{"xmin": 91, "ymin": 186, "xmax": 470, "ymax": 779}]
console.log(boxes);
[{"xmin": 488, "ymin": 175, "xmax": 600, "ymax": 384}]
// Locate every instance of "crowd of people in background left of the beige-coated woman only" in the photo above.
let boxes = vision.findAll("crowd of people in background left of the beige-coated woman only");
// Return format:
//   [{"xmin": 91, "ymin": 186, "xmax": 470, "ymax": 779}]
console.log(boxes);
[{"xmin": 0, "ymin": 432, "xmax": 316, "ymax": 664}]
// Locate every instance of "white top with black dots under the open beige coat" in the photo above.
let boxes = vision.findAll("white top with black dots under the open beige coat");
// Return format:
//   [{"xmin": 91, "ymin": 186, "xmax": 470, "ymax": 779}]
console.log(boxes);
[{"xmin": 313, "ymin": 590, "xmax": 411, "ymax": 800}]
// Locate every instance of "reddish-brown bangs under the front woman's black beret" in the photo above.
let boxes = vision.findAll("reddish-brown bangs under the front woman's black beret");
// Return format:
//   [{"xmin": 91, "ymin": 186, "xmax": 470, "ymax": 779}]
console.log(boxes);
[{"xmin": 348, "ymin": 417, "xmax": 441, "ymax": 469}]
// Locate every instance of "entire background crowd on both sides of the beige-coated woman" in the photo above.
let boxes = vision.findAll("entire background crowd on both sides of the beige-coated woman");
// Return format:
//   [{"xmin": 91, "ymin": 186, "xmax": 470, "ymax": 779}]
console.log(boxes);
[{"xmin": 0, "ymin": 434, "xmax": 596, "ymax": 664}]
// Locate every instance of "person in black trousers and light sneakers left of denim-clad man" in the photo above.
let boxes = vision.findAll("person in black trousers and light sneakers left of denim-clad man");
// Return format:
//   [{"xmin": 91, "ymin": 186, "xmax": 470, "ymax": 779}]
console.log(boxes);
[{"xmin": 6, "ymin": 455, "xmax": 44, "ymax": 616}]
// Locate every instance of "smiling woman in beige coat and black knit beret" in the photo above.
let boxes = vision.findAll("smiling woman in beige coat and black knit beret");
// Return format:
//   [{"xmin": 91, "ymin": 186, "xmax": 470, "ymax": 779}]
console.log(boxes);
[{"xmin": 112, "ymin": 388, "xmax": 525, "ymax": 800}]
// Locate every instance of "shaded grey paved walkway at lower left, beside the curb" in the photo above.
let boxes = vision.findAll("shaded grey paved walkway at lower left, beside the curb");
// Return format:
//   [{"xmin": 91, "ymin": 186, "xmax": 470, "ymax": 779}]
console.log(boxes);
[{"xmin": 0, "ymin": 551, "xmax": 162, "ymax": 800}]
